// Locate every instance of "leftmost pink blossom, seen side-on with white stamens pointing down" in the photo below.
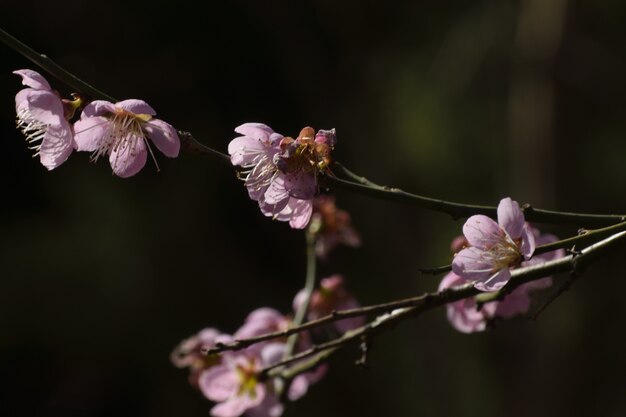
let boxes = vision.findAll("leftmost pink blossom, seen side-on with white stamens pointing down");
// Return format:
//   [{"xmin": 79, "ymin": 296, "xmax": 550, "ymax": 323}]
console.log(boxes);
[{"xmin": 13, "ymin": 69, "xmax": 79, "ymax": 170}]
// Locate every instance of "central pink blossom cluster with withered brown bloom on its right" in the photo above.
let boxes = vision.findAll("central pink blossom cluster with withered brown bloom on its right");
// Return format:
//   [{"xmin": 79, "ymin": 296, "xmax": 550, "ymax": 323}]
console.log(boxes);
[{"xmin": 228, "ymin": 123, "xmax": 336, "ymax": 229}]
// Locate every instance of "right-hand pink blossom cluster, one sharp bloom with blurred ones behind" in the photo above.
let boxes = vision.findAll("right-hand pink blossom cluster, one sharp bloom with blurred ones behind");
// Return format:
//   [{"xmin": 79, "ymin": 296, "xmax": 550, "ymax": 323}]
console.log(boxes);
[{"xmin": 439, "ymin": 198, "xmax": 565, "ymax": 333}]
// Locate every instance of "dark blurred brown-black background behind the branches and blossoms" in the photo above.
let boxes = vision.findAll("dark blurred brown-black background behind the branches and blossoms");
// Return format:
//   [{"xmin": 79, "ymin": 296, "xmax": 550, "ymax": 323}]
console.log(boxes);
[{"xmin": 0, "ymin": 0, "xmax": 626, "ymax": 417}]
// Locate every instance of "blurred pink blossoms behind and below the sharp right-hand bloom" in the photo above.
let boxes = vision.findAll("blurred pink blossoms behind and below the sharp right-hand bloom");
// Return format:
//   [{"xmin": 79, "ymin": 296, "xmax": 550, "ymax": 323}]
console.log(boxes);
[{"xmin": 439, "ymin": 224, "xmax": 565, "ymax": 333}]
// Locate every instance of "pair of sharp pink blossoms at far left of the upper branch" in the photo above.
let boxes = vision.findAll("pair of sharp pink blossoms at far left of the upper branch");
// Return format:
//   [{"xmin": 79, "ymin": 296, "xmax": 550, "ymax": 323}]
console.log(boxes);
[{"xmin": 13, "ymin": 69, "xmax": 180, "ymax": 178}]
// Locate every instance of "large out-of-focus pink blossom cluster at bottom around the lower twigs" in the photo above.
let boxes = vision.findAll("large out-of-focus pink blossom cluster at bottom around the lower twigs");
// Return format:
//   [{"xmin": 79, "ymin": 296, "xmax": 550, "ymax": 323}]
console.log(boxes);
[{"xmin": 171, "ymin": 275, "xmax": 362, "ymax": 417}]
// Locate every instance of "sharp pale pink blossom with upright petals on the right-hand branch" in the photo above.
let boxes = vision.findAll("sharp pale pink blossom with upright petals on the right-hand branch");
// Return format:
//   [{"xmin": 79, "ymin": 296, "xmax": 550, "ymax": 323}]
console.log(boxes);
[{"xmin": 452, "ymin": 198, "xmax": 535, "ymax": 291}]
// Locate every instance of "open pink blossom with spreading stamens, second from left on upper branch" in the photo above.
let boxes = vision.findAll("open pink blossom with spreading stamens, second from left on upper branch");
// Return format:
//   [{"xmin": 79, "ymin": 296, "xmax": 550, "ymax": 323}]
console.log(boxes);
[{"xmin": 74, "ymin": 100, "xmax": 180, "ymax": 178}]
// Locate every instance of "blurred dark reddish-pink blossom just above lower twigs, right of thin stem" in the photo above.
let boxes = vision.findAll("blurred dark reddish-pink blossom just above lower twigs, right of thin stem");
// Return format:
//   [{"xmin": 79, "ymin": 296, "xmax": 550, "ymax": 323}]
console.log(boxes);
[{"xmin": 293, "ymin": 275, "xmax": 365, "ymax": 333}]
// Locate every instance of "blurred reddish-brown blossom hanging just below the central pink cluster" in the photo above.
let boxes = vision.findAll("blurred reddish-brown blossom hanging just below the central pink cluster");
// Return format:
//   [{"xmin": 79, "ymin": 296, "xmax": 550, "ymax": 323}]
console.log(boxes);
[{"xmin": 309, "ymin": 195, "xmax": 361, "ymax": 259}]
